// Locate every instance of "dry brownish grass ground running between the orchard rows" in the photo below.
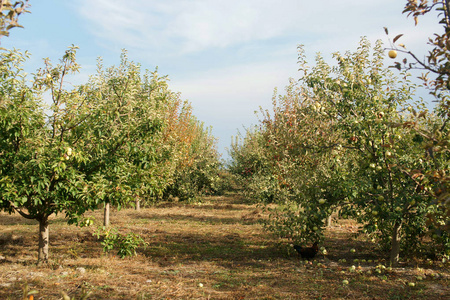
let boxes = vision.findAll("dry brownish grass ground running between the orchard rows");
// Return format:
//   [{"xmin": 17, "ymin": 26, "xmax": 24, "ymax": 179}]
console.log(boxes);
[{"xmin": 0, "ymin": 197, "xmax": 450, "ymax": 299}]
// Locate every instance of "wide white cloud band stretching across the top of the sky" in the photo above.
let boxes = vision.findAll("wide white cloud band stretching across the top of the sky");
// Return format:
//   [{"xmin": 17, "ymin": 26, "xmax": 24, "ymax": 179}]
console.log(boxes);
[{"xmin": 78, "ymin": 0, "xmax": 414, "ymax": 55}]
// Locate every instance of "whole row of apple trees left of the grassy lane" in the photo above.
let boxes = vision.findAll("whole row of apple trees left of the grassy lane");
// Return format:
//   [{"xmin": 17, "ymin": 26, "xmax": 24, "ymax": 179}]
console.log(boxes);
[{"xmin": 0, "ymin": 47, "xmax": 220, "ymax": 261}]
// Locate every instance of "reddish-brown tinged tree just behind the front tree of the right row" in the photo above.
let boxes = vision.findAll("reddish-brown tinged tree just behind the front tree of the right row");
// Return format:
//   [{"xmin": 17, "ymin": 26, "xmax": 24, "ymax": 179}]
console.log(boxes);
[{"xmin": 255, "ymin": 76, "xmax": 350, "ymax": 244}]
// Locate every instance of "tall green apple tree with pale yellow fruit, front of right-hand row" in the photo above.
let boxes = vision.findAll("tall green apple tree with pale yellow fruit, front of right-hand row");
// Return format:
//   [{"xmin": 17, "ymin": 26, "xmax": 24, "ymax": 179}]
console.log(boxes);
[{"xmin": 296, "ymin": 39, "xmax": 442, "ymax": 264}]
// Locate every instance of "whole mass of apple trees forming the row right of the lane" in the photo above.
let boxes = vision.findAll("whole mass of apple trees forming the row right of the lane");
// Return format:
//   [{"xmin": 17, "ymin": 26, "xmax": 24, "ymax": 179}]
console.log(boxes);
[{"xmin": 231, "ymin": 39, "xmax": 448, "ymax": 263}]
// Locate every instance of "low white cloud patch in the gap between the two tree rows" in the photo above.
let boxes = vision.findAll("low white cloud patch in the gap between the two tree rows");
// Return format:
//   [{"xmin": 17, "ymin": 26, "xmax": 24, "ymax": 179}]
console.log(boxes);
[{"xmin": 171, "ymin": 55, "xmax": 297, "ymax": 114}]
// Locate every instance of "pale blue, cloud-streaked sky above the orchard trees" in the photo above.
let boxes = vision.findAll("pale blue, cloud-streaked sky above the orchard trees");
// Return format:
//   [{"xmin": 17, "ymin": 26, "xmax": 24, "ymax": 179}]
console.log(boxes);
[{"xmin": 1, "ymin": 0, "xmax": 441, "ymax": 158}]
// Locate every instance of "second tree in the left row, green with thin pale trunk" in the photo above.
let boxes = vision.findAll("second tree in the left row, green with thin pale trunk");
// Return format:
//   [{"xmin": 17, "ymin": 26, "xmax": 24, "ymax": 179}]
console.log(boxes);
[{"xmin": 76, "ymin": 56, "xmax": 172, "ymax": 226}]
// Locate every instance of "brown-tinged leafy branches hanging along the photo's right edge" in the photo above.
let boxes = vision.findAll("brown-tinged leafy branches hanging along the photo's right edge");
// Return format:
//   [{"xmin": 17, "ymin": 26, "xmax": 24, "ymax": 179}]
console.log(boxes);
[{"xmin": 386, "ymin": 0, "xmax": 450, "ymax": 232}]
